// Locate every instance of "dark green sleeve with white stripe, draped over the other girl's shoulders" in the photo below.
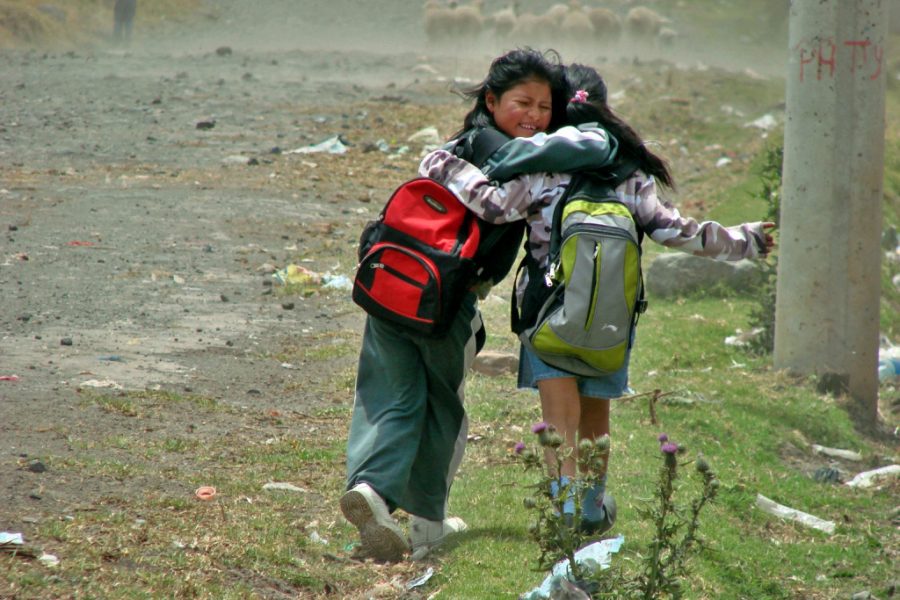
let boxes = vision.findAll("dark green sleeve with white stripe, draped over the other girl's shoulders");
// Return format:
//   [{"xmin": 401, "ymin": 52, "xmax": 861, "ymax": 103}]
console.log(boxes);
[{"xmin": 484, "ymin": 123, "xmax": 618, "ymax": 181}]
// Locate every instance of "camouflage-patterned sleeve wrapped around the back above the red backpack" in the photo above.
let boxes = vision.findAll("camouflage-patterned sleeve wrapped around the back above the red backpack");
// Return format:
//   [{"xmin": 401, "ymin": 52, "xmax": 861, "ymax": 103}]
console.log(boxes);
[{"xmin": 419, "ymin": 150, "xmax": 534, "ymax": 223}]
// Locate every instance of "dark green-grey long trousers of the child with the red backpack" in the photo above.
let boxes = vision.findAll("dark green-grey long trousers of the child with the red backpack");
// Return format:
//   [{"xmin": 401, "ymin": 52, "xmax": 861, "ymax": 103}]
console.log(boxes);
[{"xmin": 347, "ymin": 295, "xmax": 481, "ymax": 521}]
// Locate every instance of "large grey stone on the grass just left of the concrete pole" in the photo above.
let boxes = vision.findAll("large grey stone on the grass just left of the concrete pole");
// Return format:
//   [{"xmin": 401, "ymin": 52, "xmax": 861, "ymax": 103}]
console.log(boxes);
[{"xmin": 646, "ymin": 252, "xmax": 762, "ymax": 297}]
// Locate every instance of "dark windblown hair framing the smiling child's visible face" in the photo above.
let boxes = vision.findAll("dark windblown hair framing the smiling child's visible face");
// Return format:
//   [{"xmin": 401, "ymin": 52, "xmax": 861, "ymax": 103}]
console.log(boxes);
[{"xmin": 452, "ymin": 48, "xmax": 569, "ymax": 139}]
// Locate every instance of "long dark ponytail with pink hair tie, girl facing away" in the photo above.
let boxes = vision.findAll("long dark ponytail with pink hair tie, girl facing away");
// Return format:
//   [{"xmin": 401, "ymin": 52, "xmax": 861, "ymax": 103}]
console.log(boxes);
[{"xmin": 566, "ymin": 64, "xmax": 675, "ymax": 189}]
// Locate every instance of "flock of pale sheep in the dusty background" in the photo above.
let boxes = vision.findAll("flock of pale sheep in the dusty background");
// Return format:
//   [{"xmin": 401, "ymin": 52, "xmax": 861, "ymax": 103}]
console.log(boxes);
[{"xmin": 423, "ymin": 0, "xmax": 678, "ymax": 54}]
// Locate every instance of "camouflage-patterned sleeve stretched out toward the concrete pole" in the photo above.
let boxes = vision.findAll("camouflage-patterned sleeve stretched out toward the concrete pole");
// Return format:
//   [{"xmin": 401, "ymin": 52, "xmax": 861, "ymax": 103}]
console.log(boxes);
[{"xmin": 618, "ymin": 172, "xmax": 774, "ymax": 261}]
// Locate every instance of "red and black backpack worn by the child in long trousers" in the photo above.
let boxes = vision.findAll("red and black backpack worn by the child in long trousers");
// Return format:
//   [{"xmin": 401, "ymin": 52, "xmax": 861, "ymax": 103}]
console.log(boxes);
[{"xmin": 353, "ymin": 129, "xmax": 524, "ymax": 335}]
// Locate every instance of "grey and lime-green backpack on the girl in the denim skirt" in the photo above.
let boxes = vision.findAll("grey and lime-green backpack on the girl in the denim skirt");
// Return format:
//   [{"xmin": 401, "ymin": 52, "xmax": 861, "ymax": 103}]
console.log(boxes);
[{"xmin": 512, "ymin": 161, "xmax": 647, "ymax": 377}]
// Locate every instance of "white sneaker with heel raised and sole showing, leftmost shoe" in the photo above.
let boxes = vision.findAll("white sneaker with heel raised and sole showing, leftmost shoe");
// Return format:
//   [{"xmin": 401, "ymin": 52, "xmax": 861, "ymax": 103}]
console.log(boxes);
[{"xmin": 341, "ymin": 483, "xmax": 409, "ymax": 562}]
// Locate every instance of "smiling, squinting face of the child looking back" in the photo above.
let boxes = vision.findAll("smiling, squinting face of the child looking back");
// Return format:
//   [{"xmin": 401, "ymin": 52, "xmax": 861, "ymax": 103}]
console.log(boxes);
[{"xmin": 485, "ymin": 79, "xmax": 553, "ymax": 137}]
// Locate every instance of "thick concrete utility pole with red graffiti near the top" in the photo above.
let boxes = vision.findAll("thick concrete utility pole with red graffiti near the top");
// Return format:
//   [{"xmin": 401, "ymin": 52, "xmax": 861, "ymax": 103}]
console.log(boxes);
[{"xmin": 775, "ymin": 0, "xmax": 888, "ymax": 423}]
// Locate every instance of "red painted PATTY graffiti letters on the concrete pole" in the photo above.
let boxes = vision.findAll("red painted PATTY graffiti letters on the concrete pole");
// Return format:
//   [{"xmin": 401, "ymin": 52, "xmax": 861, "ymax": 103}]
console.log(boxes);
[{"xmin": 794, "ymin": 37, "xmax": 884, "ymax": 81}]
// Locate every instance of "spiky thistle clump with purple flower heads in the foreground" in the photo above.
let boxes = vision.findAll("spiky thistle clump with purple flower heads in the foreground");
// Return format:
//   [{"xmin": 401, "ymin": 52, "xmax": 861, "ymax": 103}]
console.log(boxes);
[{"xmin": 515, "ymin": 423, "xmax": 719, "ymax": 600}]
